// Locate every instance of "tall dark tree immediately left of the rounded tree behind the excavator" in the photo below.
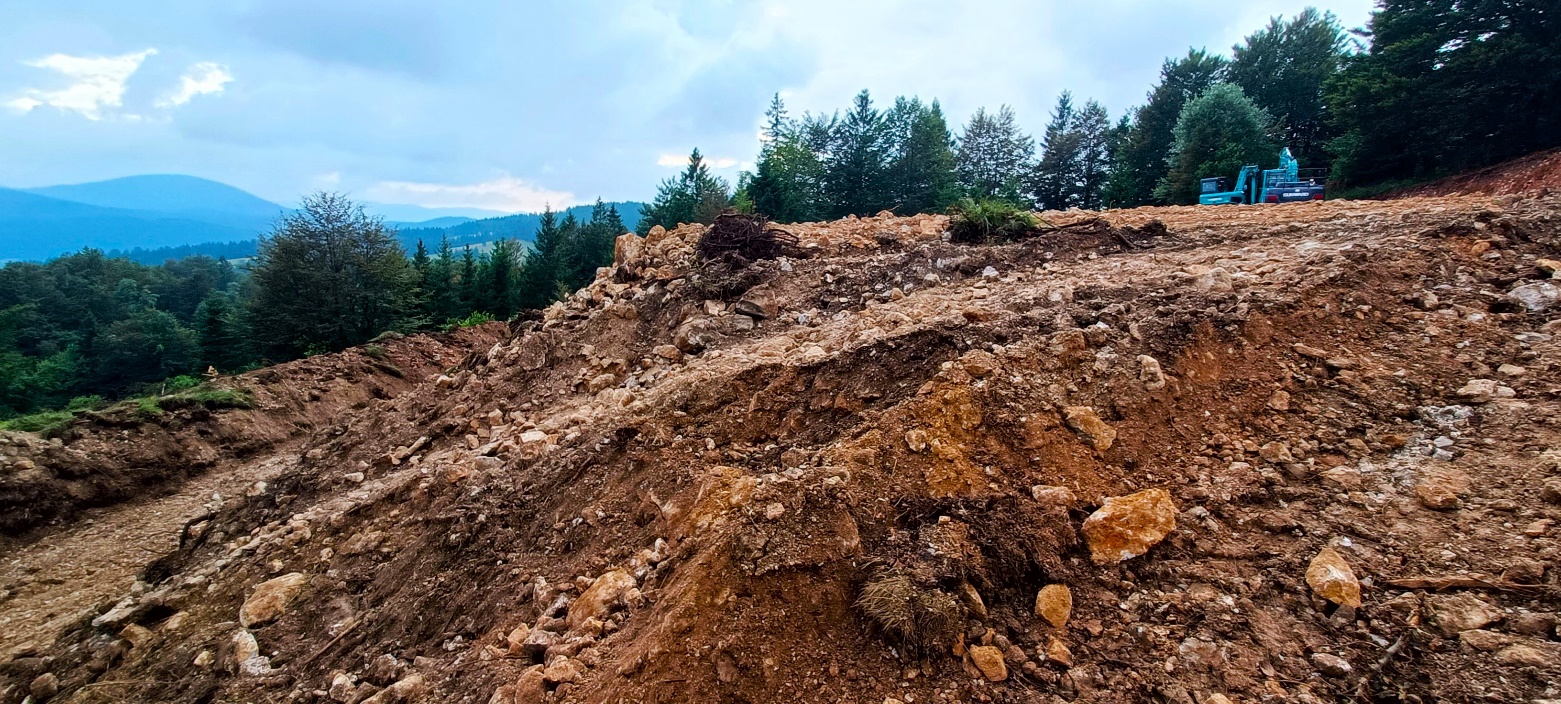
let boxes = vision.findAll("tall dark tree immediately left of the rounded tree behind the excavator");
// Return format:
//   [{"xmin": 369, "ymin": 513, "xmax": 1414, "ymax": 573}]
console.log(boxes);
[{"xmin": 1105, "ymin": 48, "xmax": 1225, "ymax": 208}]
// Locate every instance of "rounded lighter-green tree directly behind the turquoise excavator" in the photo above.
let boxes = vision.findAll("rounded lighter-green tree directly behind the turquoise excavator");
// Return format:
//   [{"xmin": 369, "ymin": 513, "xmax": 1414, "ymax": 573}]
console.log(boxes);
[{"xmin": 1155, "ymin": 83, "xmax": 1278, "ymax": 204}]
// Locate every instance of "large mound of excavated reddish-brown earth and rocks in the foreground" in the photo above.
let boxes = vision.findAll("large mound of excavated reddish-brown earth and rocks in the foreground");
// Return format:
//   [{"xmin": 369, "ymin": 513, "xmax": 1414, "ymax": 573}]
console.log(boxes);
[{"xmin": 0, "ymin": 195, "xmax": 1561, "ymax": 704}]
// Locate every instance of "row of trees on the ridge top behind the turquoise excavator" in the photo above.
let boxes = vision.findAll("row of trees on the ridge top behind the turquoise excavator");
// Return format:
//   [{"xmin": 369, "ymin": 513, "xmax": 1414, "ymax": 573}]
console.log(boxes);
[{"xmin": 640, "ymin": 0, "xmax": 1561, "ymax": 233}]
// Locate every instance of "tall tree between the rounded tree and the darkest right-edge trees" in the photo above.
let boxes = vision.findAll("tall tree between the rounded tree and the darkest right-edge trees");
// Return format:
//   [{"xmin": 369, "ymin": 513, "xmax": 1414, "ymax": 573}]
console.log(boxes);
[{"xmin": 1227, "ymin": 8, "xmax": 1349, "ymax": 165}]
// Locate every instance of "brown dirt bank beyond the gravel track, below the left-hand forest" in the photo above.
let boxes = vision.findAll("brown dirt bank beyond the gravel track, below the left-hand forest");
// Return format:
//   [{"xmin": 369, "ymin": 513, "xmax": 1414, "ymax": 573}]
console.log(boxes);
[{"xmin": 0, "ymin": 326, "xmax": 503, "ymax": 537}]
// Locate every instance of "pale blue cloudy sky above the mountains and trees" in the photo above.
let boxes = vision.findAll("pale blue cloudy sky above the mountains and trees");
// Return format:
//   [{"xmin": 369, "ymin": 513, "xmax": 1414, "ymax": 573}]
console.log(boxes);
[{"xmin": 0, "ymin": 0, "xmax": 1372, "ymax": 212}]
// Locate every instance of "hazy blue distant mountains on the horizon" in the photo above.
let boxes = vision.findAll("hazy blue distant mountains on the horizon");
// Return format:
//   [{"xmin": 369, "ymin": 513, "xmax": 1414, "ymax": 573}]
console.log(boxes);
[{"xmin": 0, "ymin": 175, "xmax": 642, "ymax": 262}]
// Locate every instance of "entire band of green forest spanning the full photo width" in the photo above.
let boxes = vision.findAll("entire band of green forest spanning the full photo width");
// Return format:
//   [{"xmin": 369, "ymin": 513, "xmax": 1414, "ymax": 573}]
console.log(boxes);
[{"xmin": 0, "ymin": 0, "xmax": 1561, "ymax": 420}]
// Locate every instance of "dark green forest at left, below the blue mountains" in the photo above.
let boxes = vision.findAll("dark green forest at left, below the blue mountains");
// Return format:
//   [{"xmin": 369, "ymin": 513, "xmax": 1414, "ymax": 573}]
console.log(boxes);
[{"xmin": 0, "ymin": 194, "xmax": 624, "ymax": 418}]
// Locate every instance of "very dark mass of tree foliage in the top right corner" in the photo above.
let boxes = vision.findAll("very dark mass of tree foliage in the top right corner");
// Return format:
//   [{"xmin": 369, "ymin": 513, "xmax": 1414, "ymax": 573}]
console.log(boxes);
[{"xmin": 1325, "ymin": 0, "xmax": 1561, "ymax": 186}]
